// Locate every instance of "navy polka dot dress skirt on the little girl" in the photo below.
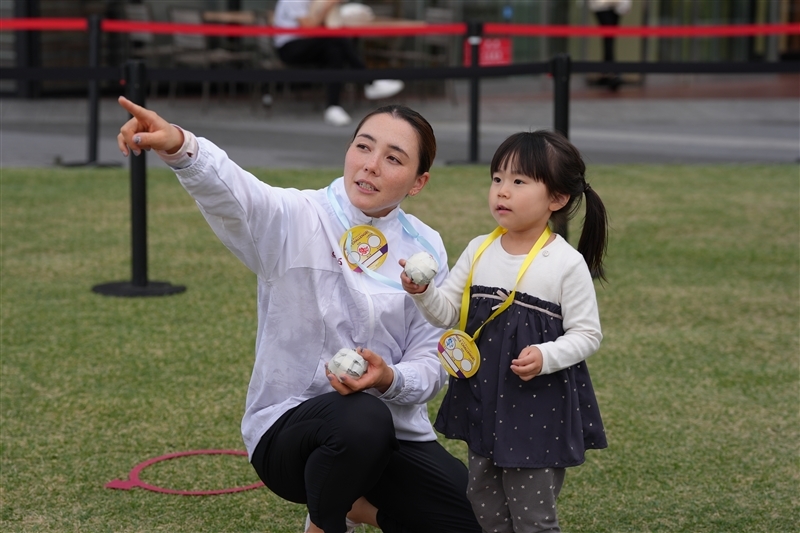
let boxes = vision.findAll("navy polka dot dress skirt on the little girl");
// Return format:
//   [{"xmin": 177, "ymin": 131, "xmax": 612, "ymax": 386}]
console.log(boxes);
[{"xmin": 434, "ymin": 286, "xmax": 608, "ymax": 468}]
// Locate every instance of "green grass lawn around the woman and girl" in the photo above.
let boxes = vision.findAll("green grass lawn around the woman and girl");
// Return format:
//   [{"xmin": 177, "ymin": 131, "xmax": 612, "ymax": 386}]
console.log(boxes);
[{"xmin": 0, "ymin": 165, "xmax": 800, "ymax": 533}]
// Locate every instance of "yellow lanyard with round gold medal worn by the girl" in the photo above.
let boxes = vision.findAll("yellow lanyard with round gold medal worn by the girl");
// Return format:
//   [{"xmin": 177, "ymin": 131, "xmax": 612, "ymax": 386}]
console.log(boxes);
[{"xmin": 438, "ymin": 226, "xmax": 553, "ymax": 379}]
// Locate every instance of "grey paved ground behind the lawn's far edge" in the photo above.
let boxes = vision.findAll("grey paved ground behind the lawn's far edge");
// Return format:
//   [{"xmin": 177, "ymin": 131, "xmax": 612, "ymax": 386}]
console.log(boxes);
[{"xmin": 0, "ymin": 74, "xmax": 800, "ymax": 168}]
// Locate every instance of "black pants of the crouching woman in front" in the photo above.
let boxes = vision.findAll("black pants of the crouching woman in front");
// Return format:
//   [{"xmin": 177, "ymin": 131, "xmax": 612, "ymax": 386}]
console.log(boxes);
[{"xmin": 252, "ymin": 392, "xmax": 481, "ymax": 533}]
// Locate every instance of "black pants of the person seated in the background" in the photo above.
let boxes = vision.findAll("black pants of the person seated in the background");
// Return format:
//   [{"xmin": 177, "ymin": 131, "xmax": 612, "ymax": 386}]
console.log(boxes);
[{"xmin": 278, "ymin": 37, "xmax": 366, "ymax": 106}]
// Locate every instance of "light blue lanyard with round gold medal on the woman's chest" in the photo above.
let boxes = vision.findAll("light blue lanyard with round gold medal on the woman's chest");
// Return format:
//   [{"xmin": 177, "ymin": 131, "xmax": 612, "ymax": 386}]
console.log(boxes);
[{"xmin": 326, "ymin": 180, "xmax": 440, "ymax": 290}]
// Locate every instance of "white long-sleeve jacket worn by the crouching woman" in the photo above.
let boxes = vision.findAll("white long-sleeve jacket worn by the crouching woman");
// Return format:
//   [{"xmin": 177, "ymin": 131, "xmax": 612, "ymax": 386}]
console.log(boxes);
[{"xmin": 159, "ymin": 132, "xmax": 448, "ymax": 456}]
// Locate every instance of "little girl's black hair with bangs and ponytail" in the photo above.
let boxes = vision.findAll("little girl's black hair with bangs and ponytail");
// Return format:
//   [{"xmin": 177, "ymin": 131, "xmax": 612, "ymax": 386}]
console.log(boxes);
[{"xmin": 490, "ymin": 130, "xmax": 608, "ymax": 279}]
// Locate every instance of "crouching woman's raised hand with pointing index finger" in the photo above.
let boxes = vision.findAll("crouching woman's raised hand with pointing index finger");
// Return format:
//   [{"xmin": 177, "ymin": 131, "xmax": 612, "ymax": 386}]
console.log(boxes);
[{"xmin": 117, "ymin": 96, "xmax": 183, "ymax": 157}]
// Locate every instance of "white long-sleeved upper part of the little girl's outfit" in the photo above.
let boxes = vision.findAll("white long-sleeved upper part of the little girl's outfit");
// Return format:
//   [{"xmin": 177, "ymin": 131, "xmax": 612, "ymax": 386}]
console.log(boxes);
[{"xmin": 413, "ymin": 235, "xmax": 603, "ymax": 374}]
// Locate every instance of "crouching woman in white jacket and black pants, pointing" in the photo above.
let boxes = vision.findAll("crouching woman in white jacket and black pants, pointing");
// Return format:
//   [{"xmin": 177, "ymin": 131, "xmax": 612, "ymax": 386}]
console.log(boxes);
[{"xmin": 117, "ymin": 98, "xmax": 480, "ymax": 533}]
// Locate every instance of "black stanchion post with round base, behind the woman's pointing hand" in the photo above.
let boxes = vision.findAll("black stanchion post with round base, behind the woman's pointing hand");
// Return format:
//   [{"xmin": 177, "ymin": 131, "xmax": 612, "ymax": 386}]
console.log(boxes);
[{"xmin": 92, "ymin": 61, "xmax": 186, "ymax": 296}]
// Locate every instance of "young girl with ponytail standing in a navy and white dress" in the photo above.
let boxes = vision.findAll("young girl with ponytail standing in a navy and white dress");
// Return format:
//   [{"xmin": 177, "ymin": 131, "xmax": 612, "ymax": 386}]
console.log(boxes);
[{"xmin": 400, "ymin": 131, "xmax": 607, "ymax": 532}]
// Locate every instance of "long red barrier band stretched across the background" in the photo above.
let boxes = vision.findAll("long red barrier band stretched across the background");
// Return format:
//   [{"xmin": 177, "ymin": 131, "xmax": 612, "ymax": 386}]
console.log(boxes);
[{"xmin": 0, "ymin": 18, "xmax": 800, "ymax": 38}]
